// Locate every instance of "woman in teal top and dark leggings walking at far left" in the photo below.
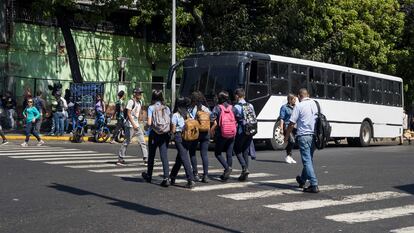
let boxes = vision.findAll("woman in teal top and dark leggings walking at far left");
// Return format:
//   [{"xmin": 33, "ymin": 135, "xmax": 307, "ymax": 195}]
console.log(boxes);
[{"xmin": 21, "ymin": 98, "xmax": 45, "ymax": 147}]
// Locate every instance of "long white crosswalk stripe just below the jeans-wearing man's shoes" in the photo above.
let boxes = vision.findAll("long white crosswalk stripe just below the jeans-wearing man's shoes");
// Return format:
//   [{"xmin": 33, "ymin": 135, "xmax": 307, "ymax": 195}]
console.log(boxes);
[{"xmin": 265, "ymin": 191, "xmax": 410, "ymax": 211}]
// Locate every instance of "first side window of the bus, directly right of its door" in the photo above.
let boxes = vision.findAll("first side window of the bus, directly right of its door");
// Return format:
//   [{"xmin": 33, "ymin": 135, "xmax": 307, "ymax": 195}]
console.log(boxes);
[{"xmin": 270, "ymin": 62, "xmax": 289, "ymax": 95}]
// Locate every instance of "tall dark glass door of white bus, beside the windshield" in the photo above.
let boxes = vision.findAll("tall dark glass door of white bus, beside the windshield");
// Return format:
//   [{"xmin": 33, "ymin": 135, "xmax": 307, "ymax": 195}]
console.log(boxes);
[{"xmin": 246, "ymin": 60, "xmax": 270, "ymax": 111}]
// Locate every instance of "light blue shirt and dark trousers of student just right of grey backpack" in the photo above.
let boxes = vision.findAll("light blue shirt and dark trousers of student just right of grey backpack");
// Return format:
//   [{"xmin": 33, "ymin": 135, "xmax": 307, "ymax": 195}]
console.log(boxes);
[{"xmin": 170, "ymin": 112, "xmax": 194, "ymax": 182}]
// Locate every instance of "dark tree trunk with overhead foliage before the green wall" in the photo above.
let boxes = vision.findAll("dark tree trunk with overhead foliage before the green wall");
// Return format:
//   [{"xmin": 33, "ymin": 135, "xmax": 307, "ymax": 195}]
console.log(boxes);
[{"xmin": 32, "ymin": 0, "xmax": 133, "ymax": 83}]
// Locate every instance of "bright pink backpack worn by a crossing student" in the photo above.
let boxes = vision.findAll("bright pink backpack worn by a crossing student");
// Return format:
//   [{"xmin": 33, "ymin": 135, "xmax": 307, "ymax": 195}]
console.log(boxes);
[{"xmin": 219, "ymin": 104, "xmax": 237, "ymax": 138}]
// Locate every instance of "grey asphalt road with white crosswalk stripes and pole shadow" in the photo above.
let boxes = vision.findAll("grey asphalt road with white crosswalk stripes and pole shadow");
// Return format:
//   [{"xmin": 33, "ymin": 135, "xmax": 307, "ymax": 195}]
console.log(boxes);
[{"xmin": 0, "ymin": 142, "xmax": 414, "ymax": 233}]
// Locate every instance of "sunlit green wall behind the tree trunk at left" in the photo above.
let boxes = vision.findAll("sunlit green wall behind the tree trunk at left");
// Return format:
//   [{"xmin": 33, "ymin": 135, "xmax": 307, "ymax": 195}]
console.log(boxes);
[{"xmin": 0, "ymin": 23, "xmax": 170, "ymax": 103}]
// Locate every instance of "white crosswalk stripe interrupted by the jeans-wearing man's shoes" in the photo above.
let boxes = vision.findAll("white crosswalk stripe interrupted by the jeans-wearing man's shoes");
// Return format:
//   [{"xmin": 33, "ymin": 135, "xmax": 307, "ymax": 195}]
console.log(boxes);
[{"xmin": 218, "ymin": 184, "xmax": 362, "ymax": 201}]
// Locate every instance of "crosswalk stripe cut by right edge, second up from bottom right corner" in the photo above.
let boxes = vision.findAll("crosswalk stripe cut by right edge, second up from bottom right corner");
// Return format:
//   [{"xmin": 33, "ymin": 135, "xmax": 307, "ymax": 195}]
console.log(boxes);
[{"xmin": 325, "ymin": 205, "xmax": 414, "ymax": 224}]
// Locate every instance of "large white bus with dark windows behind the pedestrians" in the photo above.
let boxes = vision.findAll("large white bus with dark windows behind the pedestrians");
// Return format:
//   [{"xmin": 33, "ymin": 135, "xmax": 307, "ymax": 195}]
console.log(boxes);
[{"xmin": 169, "ymin": 51, "xmax": 403, "ymax": 149}]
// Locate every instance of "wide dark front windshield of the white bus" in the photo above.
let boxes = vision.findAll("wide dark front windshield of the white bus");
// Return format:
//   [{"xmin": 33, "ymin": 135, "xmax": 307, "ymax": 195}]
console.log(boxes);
[{"xmin": 180, "ymin": 64, "xmax": 239, "ymax": 99}]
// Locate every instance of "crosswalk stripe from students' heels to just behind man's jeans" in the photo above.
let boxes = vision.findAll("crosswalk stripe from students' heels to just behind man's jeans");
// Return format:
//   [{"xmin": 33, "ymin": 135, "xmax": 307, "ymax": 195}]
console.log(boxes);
[{"xmin": 191, "ymin": 179, "xmax": 296, "ymax": 192}]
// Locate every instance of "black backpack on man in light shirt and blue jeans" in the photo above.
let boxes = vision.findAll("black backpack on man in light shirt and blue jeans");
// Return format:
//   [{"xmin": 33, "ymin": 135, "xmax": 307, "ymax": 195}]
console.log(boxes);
[{"xmin": 315, "ymin": 101, "xmax": 331, "ymax": 150}]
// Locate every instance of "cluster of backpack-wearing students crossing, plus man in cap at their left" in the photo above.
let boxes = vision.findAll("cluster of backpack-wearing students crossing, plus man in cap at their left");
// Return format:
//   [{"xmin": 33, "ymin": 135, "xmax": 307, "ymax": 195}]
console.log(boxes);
[{"xmin": 117, "ymin": 88, "xmax": 257, "ymax": 188}]
